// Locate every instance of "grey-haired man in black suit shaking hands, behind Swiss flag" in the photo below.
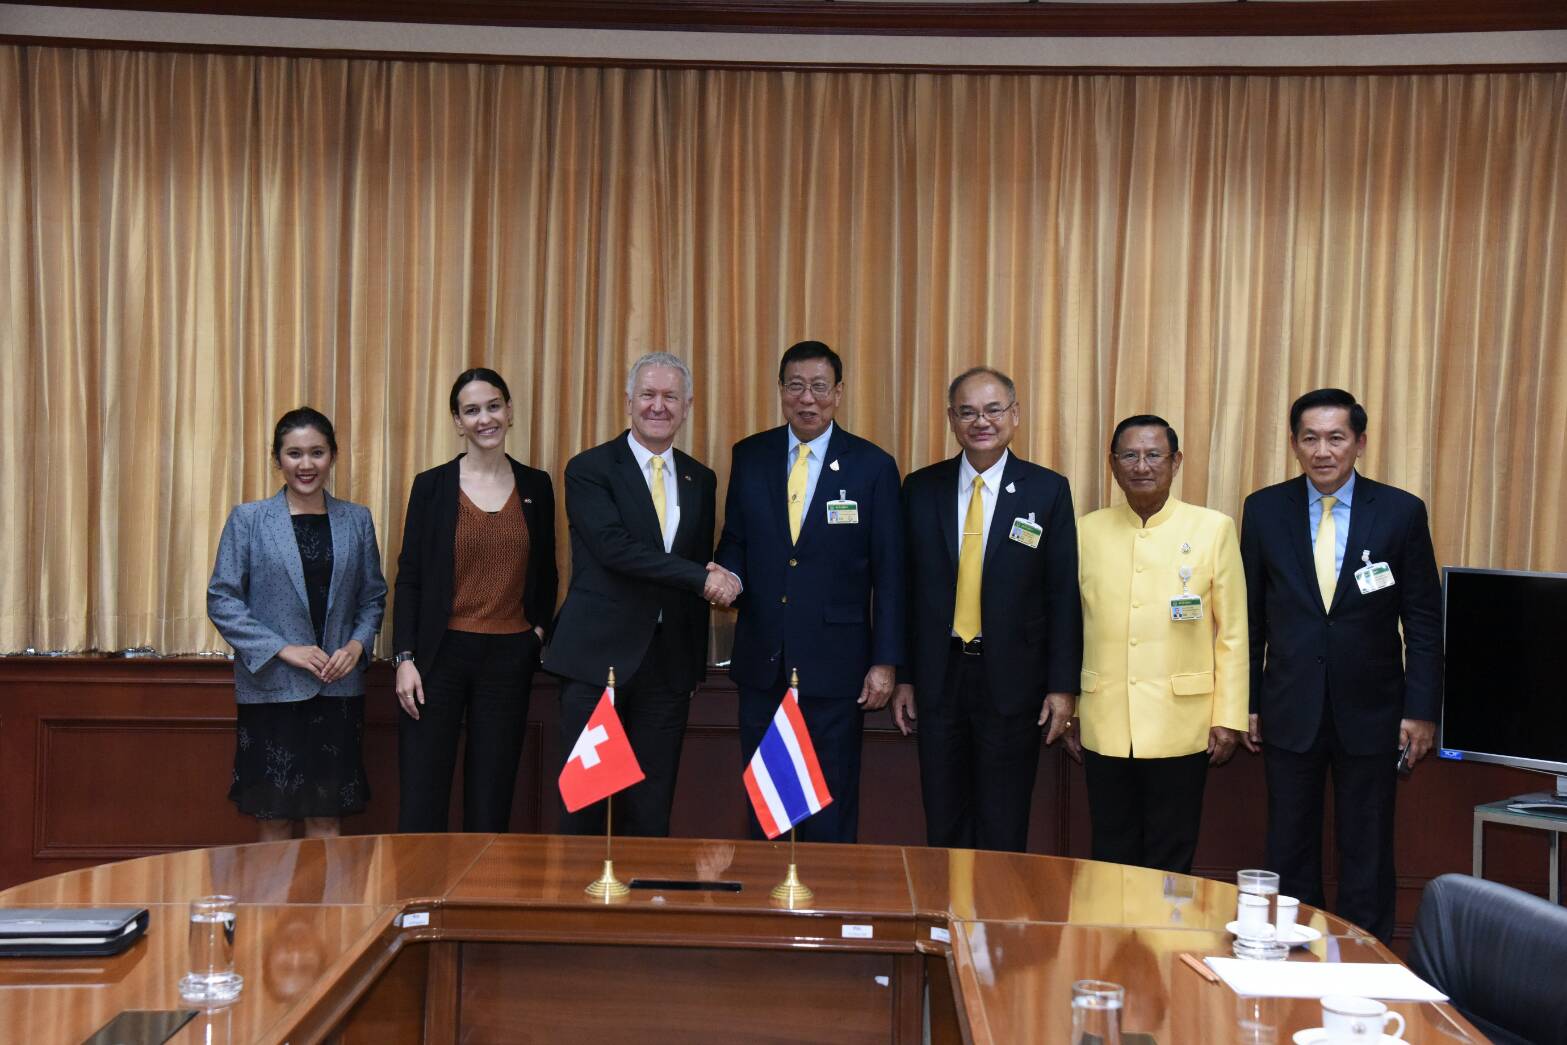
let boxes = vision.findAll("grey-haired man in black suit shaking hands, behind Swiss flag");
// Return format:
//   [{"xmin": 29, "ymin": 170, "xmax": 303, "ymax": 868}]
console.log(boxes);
[{"xmin": 544, "ymin": 353, "xmax": 736, "ymax": 835}]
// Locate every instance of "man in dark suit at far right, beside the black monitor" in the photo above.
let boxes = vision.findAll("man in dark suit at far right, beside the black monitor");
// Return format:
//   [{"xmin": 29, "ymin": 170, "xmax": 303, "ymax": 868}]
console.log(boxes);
[{"xmin": 1241, "ymin": 389, "xmax": 1442, "ymax": 942}]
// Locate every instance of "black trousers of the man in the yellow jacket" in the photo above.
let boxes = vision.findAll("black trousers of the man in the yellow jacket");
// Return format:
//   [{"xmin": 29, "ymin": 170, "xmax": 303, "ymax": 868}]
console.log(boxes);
[{"xmin": 1083, "ymin": 747, "xmax": 1208, "ymax": 874}]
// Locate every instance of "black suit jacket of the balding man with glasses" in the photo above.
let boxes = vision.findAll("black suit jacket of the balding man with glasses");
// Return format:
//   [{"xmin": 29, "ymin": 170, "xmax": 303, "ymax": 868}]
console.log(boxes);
[{"xmin": 903, "ymin": 454, "xmax": 1083, "ymax": 714}]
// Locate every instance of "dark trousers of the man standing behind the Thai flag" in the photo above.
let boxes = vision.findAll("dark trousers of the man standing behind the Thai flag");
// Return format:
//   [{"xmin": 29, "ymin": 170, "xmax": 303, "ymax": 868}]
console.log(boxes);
[{"xmin": 735, "ymin": 671, "xmax": 865, "ymax": 841}]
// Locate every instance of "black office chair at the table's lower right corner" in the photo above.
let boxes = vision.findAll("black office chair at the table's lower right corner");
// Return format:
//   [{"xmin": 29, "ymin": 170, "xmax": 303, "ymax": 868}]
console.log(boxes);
[{"xmin": 1409, "ymin": 874, "xmax": 1567, "ymax": 1045}]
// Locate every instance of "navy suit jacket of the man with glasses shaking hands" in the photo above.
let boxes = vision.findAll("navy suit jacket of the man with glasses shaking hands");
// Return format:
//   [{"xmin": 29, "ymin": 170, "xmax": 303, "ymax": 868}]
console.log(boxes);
[{"xmin": 713, "ymin": 425, "xmax": 904, "ymax": 700}]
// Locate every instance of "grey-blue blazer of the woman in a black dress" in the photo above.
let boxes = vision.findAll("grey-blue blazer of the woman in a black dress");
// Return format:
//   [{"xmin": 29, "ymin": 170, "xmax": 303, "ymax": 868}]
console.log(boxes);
[{"xmin": 207, "ymin": 490, "xmax": 387, "ymax": 703}]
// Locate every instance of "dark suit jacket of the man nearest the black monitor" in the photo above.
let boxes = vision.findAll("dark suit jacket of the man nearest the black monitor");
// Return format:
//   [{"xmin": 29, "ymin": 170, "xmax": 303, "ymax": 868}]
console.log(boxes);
[{"xmin": 1241, "ymin": 475, "xmax": 1442, "ymax": 765}]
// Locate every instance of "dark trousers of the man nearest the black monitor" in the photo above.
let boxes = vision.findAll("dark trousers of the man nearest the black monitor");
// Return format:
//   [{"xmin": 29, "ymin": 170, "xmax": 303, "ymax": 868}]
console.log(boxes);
[{"xmin": 1263, "ymin": 708, "xmax": 1398, "ymax": 943}]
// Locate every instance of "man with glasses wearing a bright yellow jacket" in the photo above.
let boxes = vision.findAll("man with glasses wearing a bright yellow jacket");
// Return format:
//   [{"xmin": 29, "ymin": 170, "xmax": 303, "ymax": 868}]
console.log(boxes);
[{"xmin": 1072, "ymin": 414, "xmax": 1250, "ymax": 874}]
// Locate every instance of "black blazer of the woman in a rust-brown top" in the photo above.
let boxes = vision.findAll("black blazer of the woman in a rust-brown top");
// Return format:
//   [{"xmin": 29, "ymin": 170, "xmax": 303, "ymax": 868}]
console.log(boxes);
[{"xmin": 392, "ymin": 454, "xmax": 561, "ymax": 674}]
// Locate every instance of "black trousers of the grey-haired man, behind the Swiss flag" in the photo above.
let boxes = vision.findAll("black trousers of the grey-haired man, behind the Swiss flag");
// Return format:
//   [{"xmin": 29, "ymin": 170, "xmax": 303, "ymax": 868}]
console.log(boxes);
[{"xmin": 556, "ymin": 628, "xmax": 689, "ymax": 838}]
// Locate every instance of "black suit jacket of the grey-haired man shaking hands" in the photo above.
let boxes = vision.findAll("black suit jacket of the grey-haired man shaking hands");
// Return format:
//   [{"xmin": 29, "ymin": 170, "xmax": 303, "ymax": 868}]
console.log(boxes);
[{"xmin": 544, "ymin": 432, "xmax": 718, "ymax": 689}]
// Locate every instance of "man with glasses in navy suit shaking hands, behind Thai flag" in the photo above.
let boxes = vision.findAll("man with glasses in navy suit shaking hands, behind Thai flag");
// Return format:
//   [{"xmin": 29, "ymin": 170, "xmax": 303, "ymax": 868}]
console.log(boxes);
[{"xmin": 713, "ymin": 342, "xmax": 904, "ymax": 841}]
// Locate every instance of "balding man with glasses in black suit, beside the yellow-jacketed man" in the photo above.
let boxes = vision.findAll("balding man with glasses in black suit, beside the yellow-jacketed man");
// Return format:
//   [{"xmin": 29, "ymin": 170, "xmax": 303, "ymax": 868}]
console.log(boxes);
[{"xmin": 893, "ymin": 367, "xmax": 1083, "ymax": 852}]
